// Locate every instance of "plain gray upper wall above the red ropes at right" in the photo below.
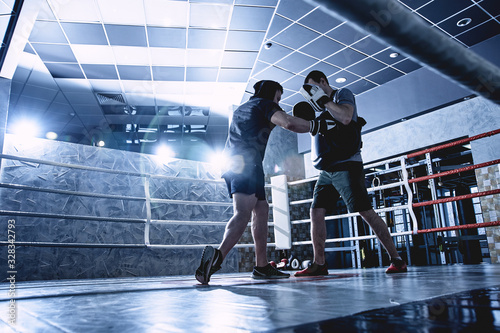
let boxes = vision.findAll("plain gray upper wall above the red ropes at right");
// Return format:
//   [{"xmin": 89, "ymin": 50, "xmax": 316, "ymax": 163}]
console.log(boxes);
[{"xmin": 362, "ymin": 97, "xmax": 500, "ymax": 164}]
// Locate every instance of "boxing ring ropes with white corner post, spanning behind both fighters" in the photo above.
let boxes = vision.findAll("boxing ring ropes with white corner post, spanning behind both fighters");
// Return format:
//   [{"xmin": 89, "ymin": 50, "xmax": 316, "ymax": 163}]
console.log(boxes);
[{"xmin": 0, "ymin": 130, "xmax": 500, "ymax": 268}]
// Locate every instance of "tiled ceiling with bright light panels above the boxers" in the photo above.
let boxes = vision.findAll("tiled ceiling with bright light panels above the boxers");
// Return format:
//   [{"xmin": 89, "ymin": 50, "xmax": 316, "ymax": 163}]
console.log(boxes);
[{"xmin": 6, "ymin": 0, "xmax": 500, "ymax": 158}]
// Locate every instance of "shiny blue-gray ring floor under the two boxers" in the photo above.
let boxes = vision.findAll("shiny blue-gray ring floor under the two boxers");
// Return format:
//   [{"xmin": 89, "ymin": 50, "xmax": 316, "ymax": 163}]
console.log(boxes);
[{"xmin": 0, "ymin": 264, "xmax": 500, "ymax": 333}]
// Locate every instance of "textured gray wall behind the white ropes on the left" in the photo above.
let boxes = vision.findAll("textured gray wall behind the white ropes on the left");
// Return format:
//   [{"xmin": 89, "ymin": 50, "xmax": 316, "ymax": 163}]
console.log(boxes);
[{"xmin": 0, "ymin": 134, "xmax": 238, "ymax": 281}]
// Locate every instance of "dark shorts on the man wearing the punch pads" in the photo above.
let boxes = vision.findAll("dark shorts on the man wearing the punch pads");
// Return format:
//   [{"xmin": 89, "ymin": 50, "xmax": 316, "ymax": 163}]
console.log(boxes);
[{"xmin": 311, "ymin": 162, "xmax": 372, "ymax": 213}]
